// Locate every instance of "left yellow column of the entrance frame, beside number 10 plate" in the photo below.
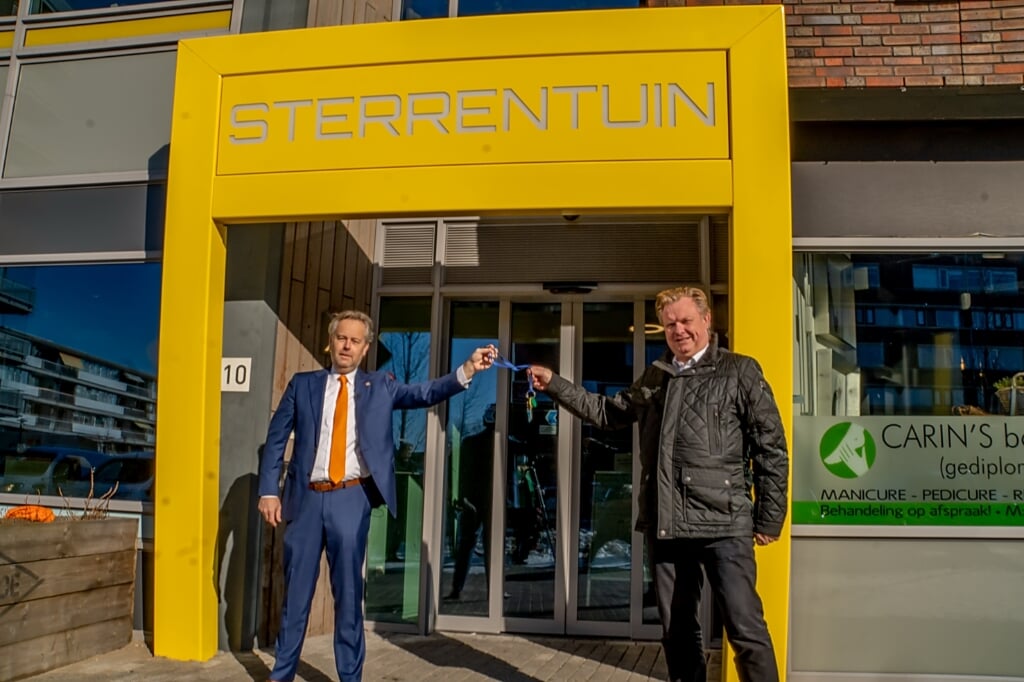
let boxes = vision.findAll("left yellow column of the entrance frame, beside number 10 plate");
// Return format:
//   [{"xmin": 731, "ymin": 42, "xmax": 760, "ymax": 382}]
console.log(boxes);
[{"xmin": 154, "ymin": 44, "xmax": 226, "ymax": 660}]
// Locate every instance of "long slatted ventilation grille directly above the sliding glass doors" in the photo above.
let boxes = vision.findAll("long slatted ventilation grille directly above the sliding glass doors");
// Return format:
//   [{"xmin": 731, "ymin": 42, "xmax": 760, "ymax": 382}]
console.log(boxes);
[{"xmin": 444, "ymin": 216, "xmax": 700, "ymax": 284}]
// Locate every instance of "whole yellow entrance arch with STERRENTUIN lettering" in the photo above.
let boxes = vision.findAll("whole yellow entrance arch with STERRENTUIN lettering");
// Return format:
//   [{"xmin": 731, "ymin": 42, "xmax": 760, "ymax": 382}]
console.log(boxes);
[{"xmin": 154, "ymin": 5, "xmax": 793, "ymax": 670}]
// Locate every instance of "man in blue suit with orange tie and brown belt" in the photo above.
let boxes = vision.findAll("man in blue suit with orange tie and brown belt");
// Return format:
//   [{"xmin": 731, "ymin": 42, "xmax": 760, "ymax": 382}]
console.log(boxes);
[{"xmin": 259, "ymin": 310, "xmax": 498, "ymax": 682}]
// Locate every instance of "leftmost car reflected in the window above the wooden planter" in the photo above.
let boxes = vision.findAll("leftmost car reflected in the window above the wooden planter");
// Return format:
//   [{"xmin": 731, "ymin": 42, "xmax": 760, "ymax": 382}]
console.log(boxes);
[{"xmin": 0, "ymin": 445, "xmax": 110, "ymax": 496}]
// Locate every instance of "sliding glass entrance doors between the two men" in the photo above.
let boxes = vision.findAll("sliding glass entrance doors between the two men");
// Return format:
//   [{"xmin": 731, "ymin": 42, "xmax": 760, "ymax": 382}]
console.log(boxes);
[{"xmin": 437, "ymin": 297, "xmax": 659, "ymax": 637}]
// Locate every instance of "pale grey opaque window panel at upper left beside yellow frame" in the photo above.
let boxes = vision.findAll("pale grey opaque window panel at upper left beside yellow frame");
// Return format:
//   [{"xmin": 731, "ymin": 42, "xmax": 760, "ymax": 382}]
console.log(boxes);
[{"xmin": 4, "ymin": 52, "xmax": 175, "ymax": 177}]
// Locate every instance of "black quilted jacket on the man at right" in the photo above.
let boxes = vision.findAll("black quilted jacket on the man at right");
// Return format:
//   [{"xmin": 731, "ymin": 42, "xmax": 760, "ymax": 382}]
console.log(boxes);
[{"xmin": 547, "ymin": 338, "xmax": 790, "ymax": 539}]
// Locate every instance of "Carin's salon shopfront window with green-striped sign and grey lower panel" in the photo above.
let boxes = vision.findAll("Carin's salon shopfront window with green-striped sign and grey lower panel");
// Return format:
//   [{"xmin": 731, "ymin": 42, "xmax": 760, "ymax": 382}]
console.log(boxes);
[{"xmin": 791, "ymin": 253, "xmax": 1024, "ymax": 676}]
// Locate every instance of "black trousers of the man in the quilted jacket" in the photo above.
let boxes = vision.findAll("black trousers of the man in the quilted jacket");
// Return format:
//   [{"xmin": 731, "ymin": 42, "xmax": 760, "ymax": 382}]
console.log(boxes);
[{"xmin": 648, "ymin": 538, "xmax": 778, "ymax": 682}]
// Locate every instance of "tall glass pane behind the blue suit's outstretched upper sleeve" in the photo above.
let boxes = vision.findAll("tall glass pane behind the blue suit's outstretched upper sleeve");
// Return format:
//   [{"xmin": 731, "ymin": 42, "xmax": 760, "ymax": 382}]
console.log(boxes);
[{"xmin": 367, "ymin": 298, "xmax": 430, "ymax": 623}]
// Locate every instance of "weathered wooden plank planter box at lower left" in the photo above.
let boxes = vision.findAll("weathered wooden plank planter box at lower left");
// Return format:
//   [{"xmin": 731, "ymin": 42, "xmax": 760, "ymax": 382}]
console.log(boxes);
[{"xmin": 0, "ymin": 518, "xmax": 138, "ymax": 680}]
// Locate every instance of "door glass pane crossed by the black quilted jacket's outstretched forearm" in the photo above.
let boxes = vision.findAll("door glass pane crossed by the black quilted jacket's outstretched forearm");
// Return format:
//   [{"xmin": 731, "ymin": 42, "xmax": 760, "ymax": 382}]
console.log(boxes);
[{"xmin": 577, "ymin": 303, "xmax": 634, "ymax": 623}]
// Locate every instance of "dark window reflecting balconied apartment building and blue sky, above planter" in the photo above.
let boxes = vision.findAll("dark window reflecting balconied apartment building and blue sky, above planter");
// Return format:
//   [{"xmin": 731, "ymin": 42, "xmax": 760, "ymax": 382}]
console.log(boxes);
[{"xmin": 0, "ymin": 263, "xmax": 161, "ymax": 502}]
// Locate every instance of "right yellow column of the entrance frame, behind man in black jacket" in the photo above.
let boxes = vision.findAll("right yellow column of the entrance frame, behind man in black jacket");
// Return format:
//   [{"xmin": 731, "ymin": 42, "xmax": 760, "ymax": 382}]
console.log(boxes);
[{"xmin": 723, "ymin": 7, "xmax": 793, "ymax": 681}]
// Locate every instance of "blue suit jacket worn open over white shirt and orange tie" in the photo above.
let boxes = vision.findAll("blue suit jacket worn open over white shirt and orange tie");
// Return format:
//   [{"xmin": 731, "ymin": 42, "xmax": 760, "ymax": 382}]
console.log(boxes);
[{"xmin": 259, "ymin": 370, "xmax": 463, "ymax": 521}]
